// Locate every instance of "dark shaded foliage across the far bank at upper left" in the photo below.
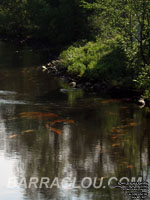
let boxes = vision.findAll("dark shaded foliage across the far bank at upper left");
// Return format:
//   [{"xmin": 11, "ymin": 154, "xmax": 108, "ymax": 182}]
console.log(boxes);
[{"xmin": 0, "ymin": 0, "xmax": 87, "ymax": 45}]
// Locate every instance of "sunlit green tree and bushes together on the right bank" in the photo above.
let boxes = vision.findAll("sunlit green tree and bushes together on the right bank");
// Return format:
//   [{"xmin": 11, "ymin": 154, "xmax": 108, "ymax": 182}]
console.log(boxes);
[{"xmin": 61, "ymin": 0, "xmax": 150, "ymax": 98}]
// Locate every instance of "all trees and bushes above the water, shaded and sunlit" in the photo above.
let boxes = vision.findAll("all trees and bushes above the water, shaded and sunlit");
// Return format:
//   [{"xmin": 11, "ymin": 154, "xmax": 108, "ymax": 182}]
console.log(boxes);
[{"xmin": 0, "ymin": 0, "xmax": 150, "ymax": 99}]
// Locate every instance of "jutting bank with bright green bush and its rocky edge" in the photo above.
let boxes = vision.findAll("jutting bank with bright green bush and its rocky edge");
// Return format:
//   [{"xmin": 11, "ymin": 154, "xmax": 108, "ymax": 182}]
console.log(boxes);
[{"xmin": 43, "ymin": 36, "xmax": 142, "ymax": 100}]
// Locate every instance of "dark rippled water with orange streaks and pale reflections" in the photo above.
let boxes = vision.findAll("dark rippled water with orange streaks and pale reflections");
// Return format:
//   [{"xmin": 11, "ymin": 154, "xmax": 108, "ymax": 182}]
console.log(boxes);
[{"xmin": 0, "ymin": 42, "xmax": 150, "ymax": 200}]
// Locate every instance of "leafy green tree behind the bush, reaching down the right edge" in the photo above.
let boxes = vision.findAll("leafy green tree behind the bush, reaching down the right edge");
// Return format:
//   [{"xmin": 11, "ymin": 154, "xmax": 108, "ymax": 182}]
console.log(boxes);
[{"xmin": 81, "ymin": 0, "xmax": 150, "ymax": 97}]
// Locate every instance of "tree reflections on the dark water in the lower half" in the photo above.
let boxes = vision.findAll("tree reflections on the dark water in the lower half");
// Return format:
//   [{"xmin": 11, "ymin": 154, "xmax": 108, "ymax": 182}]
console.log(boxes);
[{"xmin": 0, "ymin": 99, "xmax": 150, "ymax": 199}]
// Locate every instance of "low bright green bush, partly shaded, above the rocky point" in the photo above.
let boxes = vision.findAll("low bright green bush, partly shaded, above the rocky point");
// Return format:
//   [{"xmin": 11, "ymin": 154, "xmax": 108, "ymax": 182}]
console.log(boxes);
[{"xmin": 60, "ymin": 37, "xmax": 128, "ymax": 85}]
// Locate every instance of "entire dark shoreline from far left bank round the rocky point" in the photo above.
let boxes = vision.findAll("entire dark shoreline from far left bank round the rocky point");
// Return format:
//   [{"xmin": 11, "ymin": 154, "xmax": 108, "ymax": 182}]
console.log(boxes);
[{"xmin": 0, "ymin": 37, "xmax": 144, "ymax": 104}]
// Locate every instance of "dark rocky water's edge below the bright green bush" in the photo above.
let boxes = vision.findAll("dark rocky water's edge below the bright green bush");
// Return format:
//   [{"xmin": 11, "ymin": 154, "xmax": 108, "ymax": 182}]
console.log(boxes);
[{"xmin": 42, "ymin": 59, "xmax": 141, "ymax": 102}]
